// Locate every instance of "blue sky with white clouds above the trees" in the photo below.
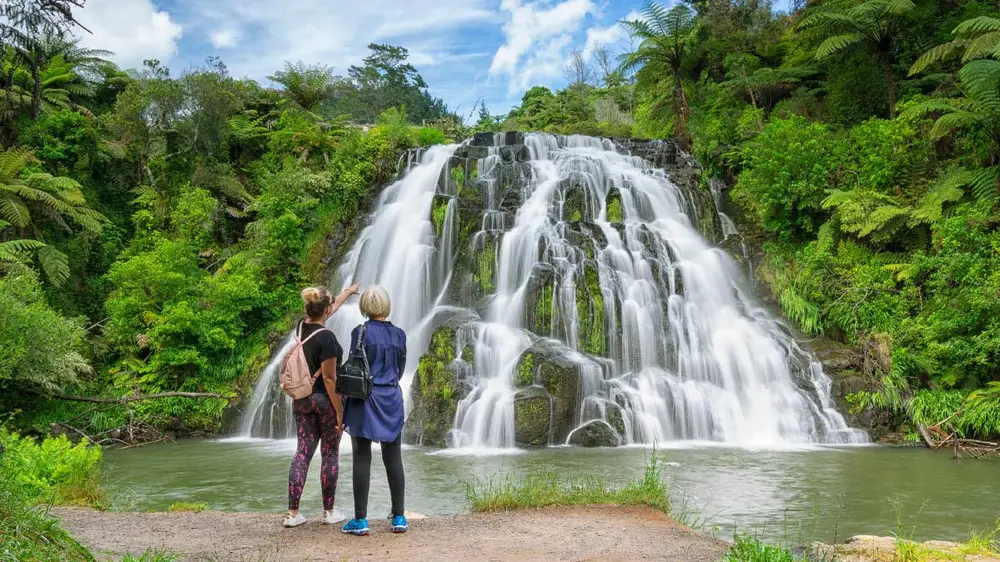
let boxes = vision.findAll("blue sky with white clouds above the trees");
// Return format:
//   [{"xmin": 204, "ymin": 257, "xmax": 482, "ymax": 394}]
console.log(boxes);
[{"xmin": 70, "ymin": 0, "xmax": 788, "ymax": 115}]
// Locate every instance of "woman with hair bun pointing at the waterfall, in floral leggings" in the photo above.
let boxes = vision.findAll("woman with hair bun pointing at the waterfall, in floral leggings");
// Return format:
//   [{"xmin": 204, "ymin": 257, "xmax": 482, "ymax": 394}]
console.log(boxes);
[{"xmin": 283, "ymin": 285, "xmax": 360, "ymax": 527}]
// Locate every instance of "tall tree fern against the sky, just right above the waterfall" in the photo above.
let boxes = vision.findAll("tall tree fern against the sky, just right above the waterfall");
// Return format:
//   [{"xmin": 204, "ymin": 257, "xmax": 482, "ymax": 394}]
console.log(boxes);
[{"xmin": 620, "ymin": 1, "xmax": 695, "ymax": 139}]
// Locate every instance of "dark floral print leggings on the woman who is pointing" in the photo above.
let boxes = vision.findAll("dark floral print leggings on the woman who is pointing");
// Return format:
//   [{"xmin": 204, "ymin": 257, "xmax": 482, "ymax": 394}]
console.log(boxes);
[{"xmin": 288, "ymin": 392, "xmax": 340, "ymax": 511}]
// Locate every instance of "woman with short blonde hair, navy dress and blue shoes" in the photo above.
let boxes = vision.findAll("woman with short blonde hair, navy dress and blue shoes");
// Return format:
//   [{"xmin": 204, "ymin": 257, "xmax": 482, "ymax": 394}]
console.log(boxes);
[{"xmin": 344, "ymin": 285, "xmax": 407, "ymax": 535}]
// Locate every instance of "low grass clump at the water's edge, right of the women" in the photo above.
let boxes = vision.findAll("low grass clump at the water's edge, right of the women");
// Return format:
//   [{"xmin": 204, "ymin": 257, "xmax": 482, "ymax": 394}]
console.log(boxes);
[{"xmin": 465, "ymin": 456, "xmax": 670, "ymax": 513}]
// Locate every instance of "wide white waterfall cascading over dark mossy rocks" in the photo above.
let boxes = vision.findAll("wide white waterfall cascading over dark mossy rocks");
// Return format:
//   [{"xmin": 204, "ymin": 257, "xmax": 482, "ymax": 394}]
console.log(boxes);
[{"xmin": 236, "ymin": 133, "xmax": 867, "ymax": 450}]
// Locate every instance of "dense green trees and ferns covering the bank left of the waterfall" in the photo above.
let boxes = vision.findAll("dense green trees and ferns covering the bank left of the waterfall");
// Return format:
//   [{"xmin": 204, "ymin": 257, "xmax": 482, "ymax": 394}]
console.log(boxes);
[{"xmin": 0, "ymin": 2, "xmax": 457, "ymax": 442}]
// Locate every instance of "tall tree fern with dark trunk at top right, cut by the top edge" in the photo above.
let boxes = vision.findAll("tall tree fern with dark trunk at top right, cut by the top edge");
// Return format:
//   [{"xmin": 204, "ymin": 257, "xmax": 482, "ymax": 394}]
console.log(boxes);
[{"xmin": 798, "ymin": 0, "xmax": 916, "ymax": 118}]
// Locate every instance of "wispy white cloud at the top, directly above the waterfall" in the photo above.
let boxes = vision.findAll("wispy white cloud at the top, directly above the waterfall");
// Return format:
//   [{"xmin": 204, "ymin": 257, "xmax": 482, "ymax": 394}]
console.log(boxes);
[{"xmin": 490, "ymin": 0, "xmax": 598, "ymax": 91}]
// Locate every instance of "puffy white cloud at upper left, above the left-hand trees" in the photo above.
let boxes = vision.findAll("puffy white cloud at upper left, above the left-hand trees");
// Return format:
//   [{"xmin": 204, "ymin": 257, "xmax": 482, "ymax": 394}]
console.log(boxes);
[{"xmin": 76, "ymin": 0, "xmax": 183, "ymax": 68}]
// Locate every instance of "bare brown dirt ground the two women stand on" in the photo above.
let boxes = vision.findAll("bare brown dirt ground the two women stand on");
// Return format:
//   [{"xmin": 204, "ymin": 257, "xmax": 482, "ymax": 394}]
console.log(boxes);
[{"xmin": 53, "ymin": 506, "xmax": 728, "ymax": 562}]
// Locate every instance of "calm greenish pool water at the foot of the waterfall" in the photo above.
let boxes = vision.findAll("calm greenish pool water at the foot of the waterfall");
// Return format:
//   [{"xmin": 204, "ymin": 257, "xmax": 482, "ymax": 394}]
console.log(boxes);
[{"xmin": 105, "ymin": 440, "xmax": 1000, "ymax": 544}]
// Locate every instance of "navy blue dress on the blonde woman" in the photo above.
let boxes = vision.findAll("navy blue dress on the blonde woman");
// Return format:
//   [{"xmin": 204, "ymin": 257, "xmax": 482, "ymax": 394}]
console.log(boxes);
[{"xmin": 344, "ymin": 320, "xmax": 406, "ymax": 443}]
